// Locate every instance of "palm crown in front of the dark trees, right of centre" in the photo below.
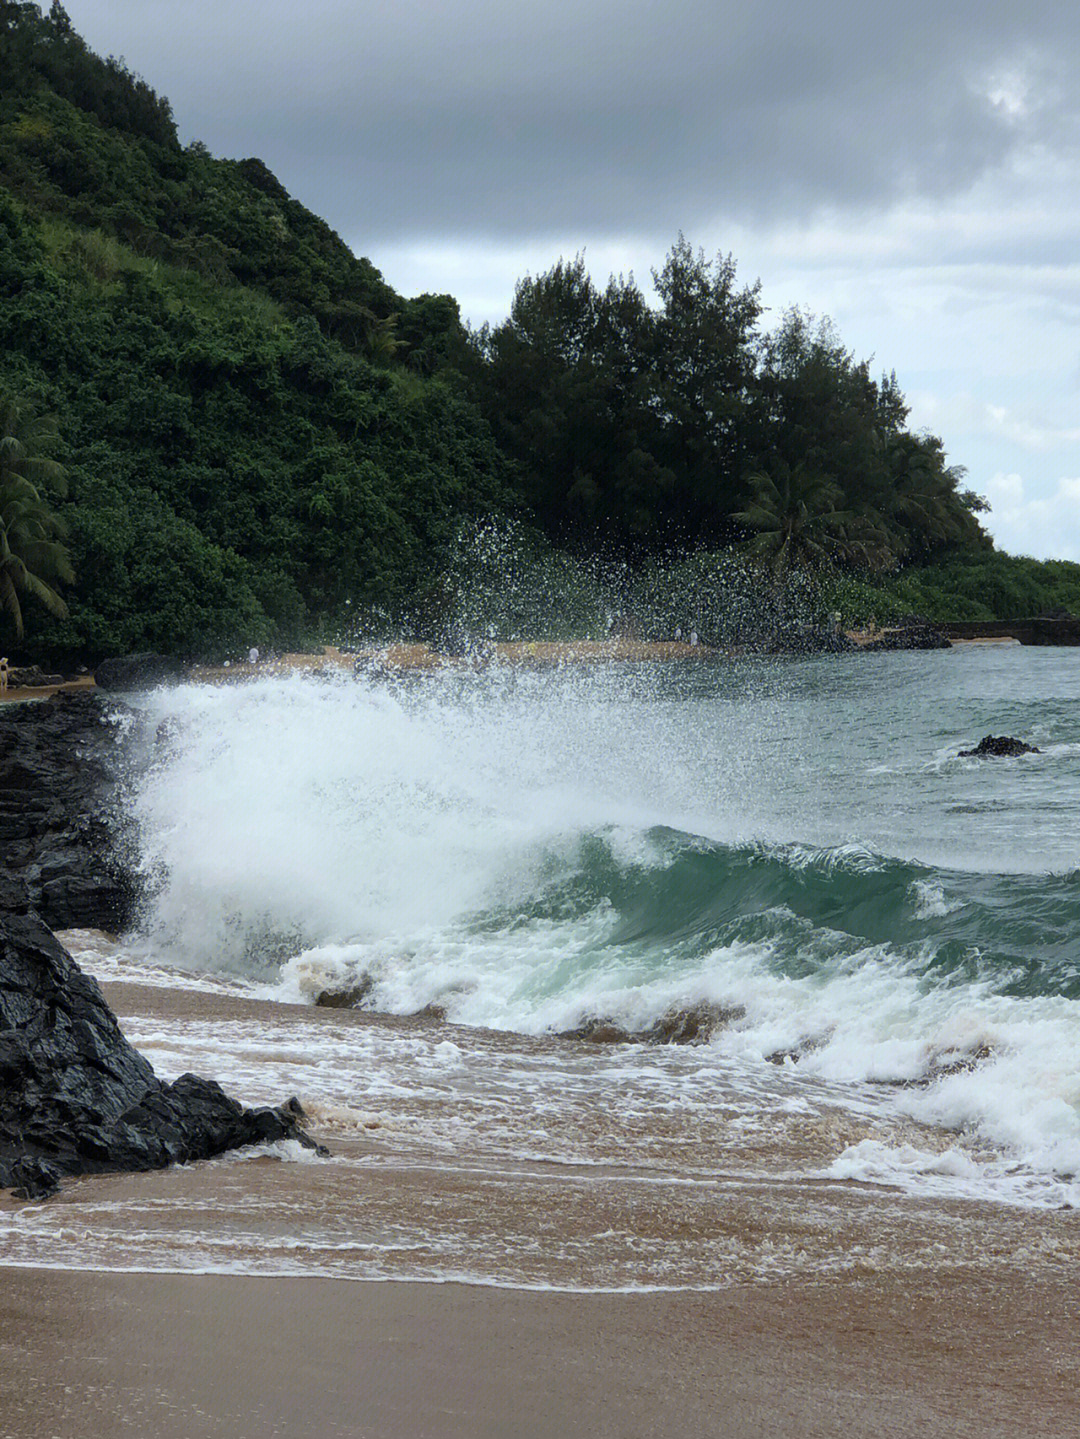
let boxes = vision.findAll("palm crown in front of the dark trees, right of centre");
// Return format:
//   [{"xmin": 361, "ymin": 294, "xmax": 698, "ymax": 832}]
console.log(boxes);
[{"xmin": 732, "ymin": 459, "xmax": 850, "ymax": 571}]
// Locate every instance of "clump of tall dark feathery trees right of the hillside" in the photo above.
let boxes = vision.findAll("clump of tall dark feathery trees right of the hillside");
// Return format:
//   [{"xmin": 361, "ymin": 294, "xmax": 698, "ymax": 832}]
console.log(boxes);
[{"xmin": 475, "ymin": 253, "xmax": 989, "ymax": 568}]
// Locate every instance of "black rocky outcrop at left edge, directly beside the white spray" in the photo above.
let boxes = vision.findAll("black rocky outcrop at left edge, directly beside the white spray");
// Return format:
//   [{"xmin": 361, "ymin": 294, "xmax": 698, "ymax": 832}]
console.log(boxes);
[{"xmin": 0, "ymin": 689, "xmax": 135, "ymax": 930}]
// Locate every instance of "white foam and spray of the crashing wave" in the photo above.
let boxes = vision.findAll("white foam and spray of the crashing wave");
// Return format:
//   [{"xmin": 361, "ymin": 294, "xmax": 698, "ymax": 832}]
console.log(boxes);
[{"xmin": 102, "ymin": 667, "xmax": 1080, "ymax": 1203}]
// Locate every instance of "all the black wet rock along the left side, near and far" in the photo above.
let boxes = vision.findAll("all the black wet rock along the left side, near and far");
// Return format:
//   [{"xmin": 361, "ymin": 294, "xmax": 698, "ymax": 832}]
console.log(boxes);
[{"xmin": 0, "ymin": 692, "xmax": 325, "ymax": 1199}]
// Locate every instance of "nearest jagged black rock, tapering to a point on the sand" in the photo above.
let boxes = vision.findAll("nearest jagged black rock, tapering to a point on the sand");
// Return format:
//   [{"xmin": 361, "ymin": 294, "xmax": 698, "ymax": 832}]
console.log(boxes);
[{"xmin": 0, "ymin": 914, "xmax": 323, "ymax": 1199}]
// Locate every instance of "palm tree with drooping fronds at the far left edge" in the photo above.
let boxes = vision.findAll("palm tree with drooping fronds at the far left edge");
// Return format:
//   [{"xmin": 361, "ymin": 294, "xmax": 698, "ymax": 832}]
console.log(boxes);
[{"xmin": 0, "ymin": 391, "xmax": 75, "ymax": 639}]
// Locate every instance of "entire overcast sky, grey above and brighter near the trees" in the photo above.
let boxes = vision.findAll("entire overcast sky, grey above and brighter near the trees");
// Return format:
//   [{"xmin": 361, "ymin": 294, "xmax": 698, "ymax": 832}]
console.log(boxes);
[{"xmin": 66, "ymin": 0, "xmax": 1080, "ymax": 560}]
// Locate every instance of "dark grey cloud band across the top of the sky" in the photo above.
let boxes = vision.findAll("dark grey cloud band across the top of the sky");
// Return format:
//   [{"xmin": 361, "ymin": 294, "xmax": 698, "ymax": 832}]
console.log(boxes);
[{"xmin": 68, "ymin": 0, "xmax": 1080, "ymax": 249}]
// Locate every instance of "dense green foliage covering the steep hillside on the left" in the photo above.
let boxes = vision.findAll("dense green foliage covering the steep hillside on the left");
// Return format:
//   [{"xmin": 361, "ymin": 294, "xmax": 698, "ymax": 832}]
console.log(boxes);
[{"xmin": 0, "ymin": 3, "xmax": 503, "ymax": 659}]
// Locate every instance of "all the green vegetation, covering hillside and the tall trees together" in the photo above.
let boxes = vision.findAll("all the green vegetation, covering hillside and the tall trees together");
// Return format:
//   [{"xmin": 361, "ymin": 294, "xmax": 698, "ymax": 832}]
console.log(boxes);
[{"xmin": 0, "ymin": 0, "xmax": 1080, "ymax": 662}]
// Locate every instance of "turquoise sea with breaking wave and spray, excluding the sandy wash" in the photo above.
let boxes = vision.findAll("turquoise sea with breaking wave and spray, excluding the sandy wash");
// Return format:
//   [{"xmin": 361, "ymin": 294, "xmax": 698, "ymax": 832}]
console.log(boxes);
[{"xmin": 122, "ymin": 646, "xmax": 1080, "ymax": 1197}]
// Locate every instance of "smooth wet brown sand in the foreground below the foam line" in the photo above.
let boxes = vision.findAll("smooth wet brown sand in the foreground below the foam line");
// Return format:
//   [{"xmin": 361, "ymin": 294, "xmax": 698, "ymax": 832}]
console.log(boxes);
[{"xmin": 0, "ymin": 1269, "xmax": 1080, "ymax": 1439}]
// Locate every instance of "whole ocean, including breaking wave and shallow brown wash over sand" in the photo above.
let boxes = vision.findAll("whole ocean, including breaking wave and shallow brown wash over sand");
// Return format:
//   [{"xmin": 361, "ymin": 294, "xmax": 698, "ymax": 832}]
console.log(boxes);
[{"xmin": 0, "ymin": 645, "xmax": 1080, "ymax": 1289}]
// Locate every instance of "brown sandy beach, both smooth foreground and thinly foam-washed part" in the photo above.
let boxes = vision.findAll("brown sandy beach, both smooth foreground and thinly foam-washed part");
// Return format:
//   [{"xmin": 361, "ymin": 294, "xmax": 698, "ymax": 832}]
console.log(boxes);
[{"xmin": 0, "ymin": 981, "xmax": 1080, "ymax": 1439}]
